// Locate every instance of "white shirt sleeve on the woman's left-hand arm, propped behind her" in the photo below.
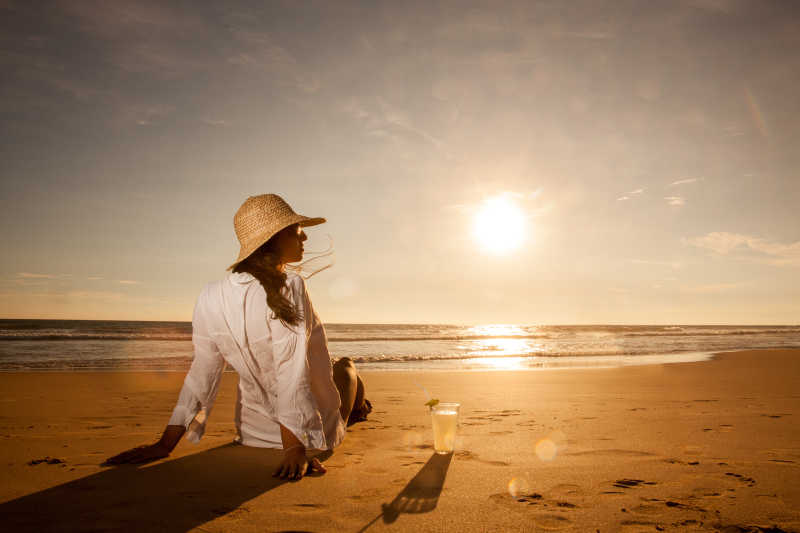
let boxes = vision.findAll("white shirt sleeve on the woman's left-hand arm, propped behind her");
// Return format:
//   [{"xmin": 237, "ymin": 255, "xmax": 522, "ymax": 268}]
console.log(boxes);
[{"xmin": 169, "ymin": 289, "xmax": 225, "ymax": 443}]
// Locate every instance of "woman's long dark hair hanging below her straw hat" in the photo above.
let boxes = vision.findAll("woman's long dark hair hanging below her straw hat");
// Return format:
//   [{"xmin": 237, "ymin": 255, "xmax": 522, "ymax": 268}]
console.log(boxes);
[{"xmin": 233, "ymin": 226, "xmax": 303, "ymax": 326}]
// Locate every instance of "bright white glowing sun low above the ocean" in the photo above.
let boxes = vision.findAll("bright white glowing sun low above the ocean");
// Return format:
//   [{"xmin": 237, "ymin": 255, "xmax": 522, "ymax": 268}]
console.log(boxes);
[{"xmin": 473, "ymin": 194, "xmax": 525, "ymax": 254}]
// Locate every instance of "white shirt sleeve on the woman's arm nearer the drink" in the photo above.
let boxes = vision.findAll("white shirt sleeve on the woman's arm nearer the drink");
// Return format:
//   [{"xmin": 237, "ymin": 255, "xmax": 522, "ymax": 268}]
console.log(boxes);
[{"xmin": 267, "ymin": 276, "xmax": 327, "ymax": 450}]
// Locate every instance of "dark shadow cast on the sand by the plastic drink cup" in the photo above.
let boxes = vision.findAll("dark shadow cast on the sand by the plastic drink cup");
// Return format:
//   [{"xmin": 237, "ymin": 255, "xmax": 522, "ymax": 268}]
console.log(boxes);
[{"xmin": 359, "ymin": 453, "xmax": 453, "ymax": 533}]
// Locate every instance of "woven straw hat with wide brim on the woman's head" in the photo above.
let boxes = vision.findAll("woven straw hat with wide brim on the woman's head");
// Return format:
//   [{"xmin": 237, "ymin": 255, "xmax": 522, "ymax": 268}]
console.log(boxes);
[{"xmin": 228, "ymin": 194, "xmax": 325, "ymax": 270}]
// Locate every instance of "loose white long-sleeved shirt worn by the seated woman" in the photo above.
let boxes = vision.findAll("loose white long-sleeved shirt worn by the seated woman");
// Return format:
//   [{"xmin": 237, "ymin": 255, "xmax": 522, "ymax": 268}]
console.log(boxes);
[{"xmin": 169, "ymin": 272, "xmax": 345, "ymax": 450}]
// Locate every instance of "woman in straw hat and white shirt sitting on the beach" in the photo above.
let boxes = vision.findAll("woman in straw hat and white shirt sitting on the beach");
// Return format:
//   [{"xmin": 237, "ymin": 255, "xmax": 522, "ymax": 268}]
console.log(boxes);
[{"xmin": 106, "ymin": 194, "xmax": 371, "ymax": 479}]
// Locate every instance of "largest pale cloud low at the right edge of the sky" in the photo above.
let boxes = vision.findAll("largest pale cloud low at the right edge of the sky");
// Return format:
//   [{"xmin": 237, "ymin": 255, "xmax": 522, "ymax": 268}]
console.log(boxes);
[{"xmin": 684, "ymin": 231, "xmax": 800, "ymax": 266}]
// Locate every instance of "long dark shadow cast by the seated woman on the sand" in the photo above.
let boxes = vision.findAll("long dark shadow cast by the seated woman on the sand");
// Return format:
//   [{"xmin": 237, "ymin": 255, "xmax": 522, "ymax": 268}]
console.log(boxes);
[{"xmin": 0, "ymin": 444, "xmax": 330, "ymax": 533}]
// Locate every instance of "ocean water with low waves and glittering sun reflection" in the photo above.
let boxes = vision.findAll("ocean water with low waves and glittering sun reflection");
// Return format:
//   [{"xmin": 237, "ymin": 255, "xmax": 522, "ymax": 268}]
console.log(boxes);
[{"xmin": 0, "ymin": 320, "xmax": 800, "ymax": 372}]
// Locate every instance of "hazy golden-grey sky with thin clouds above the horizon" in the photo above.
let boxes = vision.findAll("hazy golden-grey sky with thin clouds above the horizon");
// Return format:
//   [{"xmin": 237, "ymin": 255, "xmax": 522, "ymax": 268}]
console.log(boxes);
[{"xmin": 0, "ymin": 0, "xmax": 800, "ymax": 324}]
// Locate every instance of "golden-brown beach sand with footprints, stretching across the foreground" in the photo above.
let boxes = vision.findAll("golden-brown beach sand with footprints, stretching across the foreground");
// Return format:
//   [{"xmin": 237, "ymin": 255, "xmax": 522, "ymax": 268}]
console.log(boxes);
[{"xmin": 0, "ymin": 350, "xmax": 800, "ymax": 533}]
